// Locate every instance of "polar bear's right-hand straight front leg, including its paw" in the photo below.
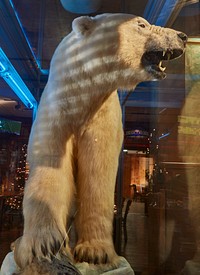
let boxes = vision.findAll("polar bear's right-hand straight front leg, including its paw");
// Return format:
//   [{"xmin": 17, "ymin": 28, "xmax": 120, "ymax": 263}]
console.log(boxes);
[{"xmin": 74, "ymin": 94, "xmax": 122, "ymax": 265}]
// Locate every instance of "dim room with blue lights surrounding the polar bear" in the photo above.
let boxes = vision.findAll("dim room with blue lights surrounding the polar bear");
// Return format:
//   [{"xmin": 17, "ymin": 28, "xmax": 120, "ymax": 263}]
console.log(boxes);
[{"xmin": 0, "ymin": 0, "xmax": 200, "ymax": 275}]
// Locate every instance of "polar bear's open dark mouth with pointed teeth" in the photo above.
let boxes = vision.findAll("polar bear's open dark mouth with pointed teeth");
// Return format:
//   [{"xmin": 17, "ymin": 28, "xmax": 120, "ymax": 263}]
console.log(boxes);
[{"xmin": 142, "ymin": 49, "xmax": 183, "ymax": 78}]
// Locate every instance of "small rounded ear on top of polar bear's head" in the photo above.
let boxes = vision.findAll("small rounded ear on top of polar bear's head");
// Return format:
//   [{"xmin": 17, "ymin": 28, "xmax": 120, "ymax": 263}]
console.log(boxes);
[{"xmin": 72, "ymin": 16, "xmax": 94, "ymax": 36}]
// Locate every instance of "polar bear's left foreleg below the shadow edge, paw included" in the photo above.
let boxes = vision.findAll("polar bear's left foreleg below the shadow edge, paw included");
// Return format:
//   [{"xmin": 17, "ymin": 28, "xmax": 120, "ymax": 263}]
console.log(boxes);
[{"xmin": 15, "ymin": 156, "xmax": 74, "ymax": 268}]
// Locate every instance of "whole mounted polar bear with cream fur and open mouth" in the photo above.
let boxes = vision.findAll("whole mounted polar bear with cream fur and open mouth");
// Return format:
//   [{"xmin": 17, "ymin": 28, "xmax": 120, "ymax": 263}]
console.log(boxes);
[{"xmin": 15, "ymin": 14, "xmax": 187, "ymax": 270}]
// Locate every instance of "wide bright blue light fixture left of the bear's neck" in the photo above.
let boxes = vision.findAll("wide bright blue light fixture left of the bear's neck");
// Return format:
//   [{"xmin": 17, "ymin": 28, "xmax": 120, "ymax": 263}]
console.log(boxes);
[{"xmin": 0, "ymin": 48, "xmax": 37, "ymax": 112}]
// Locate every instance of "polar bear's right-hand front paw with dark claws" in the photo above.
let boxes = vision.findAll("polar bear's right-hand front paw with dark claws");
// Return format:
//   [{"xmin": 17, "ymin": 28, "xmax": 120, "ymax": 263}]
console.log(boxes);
[{"xmin": 74, "ymin": 241, "xmax": 118, "ymax": 265}]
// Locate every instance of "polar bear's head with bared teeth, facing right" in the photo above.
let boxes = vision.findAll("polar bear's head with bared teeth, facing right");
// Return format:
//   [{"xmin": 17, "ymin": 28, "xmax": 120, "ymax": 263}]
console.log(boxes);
[{"xmin": 52, "ymin": 14, "xmax": 187, "ymax": 90}]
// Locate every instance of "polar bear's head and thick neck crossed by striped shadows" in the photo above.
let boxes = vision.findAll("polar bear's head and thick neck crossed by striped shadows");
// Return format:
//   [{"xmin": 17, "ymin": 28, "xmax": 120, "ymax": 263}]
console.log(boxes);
[{"xmin": 38, "ymin": 14, "xmax": 187, "ymax": 142}]
